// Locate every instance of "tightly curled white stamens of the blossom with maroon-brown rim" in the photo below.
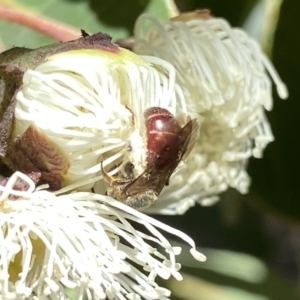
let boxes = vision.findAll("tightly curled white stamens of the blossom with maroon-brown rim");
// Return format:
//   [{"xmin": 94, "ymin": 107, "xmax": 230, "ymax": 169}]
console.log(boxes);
[{"xmin": 14, "ymin": 49, "xmax": 186, "ymax": 192}]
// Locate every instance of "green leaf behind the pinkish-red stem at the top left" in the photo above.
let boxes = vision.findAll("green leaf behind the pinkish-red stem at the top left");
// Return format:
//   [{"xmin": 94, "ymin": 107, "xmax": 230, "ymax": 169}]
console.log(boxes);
[{"xmin": 0, "ymin": 0, "xmax": 174, "ymax": 49}]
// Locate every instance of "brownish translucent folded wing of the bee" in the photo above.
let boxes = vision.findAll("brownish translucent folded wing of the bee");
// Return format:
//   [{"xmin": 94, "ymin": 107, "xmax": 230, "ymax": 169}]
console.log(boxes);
[{"xmin": 123, "ymin": 119, "xmax": 199, "ymax": 197}]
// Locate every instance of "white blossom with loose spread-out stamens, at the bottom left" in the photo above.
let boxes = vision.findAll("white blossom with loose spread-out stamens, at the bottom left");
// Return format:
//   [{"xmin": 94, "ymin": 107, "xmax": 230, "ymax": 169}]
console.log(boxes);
[{"xmin": 0, "ymin": 172, "xmax": 205, "ymax": 300}]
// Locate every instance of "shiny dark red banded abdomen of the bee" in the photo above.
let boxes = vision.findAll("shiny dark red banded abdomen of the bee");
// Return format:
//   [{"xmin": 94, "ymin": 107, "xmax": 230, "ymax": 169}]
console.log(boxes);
[{"xmin": 144, "ymin": 107, "xmax": 181, "ymax": 167}]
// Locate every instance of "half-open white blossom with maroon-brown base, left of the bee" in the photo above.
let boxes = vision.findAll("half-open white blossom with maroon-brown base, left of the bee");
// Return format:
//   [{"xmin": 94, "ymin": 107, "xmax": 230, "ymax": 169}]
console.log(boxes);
[{"xmin": 0, "ymin": 33, "xmax": 187, "ymax": 193}]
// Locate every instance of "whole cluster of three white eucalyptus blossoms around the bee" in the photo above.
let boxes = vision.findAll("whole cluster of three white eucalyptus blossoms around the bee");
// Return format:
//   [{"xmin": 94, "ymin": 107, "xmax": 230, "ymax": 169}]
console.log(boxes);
[{"xmin": 0, "ymin": 12, "xmax": 287, "ymax": 299}]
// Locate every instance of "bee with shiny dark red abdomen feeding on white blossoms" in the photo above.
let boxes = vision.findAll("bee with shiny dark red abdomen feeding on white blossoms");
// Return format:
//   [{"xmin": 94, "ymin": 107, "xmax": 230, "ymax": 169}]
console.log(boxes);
[{"xmin": 101, "ymin": 107, "xmax": 199, "ymax": 210}]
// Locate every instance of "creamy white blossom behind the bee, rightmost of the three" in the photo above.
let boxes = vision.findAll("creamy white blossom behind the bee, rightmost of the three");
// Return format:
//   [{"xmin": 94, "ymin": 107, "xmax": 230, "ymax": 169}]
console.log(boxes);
[{"xmin": 133, "ymin": 10, "xmax": 288, "ymax": 214}]
